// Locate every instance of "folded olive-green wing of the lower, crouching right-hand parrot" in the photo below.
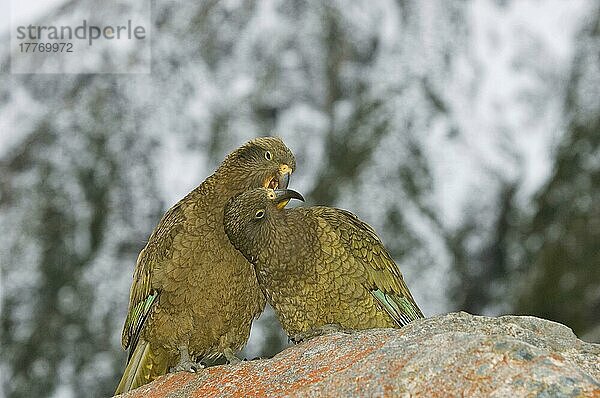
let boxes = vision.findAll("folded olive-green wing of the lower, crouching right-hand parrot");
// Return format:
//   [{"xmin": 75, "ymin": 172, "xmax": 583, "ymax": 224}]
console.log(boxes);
[{"xmin": 319, "ymin": 207, "xmax": 424, "ymax": 326}]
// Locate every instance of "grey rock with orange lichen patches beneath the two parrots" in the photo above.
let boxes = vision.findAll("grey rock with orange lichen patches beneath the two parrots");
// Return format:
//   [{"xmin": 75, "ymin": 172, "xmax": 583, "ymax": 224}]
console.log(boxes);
[{"xmin": 117, "ymin": 312, "xmax": 600, "ymax": 398}]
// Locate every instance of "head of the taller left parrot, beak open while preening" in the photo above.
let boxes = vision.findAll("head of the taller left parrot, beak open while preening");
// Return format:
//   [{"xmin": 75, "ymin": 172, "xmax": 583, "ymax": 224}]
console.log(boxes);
[{"xmin": 218, "ymin": 137, "xmax": 296, "ymax": 193}]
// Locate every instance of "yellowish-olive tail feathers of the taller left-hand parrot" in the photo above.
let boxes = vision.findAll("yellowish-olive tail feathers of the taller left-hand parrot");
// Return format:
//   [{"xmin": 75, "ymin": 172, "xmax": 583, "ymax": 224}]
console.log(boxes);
[{"xmin": 115, "ymin": 339, "xmax": 168, "ymax": 395}]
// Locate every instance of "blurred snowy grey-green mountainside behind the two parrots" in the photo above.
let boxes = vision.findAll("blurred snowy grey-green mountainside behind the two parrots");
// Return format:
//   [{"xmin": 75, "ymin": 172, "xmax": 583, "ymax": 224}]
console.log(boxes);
[{"xmin": 0, "ymin": 0, "xmax": 600, "ymax": 397}]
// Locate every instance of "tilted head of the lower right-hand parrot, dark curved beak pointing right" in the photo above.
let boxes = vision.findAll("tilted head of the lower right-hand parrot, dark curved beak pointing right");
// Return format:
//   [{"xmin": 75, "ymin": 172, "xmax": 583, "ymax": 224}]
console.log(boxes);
[{"xmin": 223, "ymin": 188, "xmax": 304, "ymax": 263}]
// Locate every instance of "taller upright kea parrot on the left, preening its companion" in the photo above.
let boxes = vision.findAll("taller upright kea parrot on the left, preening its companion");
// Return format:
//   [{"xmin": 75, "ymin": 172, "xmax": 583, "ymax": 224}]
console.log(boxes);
[{"xmin": 116, "ymin": 137, "xmax": 296, "ymax": 394}]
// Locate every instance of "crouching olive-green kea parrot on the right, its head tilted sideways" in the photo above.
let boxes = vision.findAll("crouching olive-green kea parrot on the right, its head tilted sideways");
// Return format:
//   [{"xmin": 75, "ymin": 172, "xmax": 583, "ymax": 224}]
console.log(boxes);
[{"xmin": 224, "ymin": 188, "xmax": 423, "ymax": 342}]
